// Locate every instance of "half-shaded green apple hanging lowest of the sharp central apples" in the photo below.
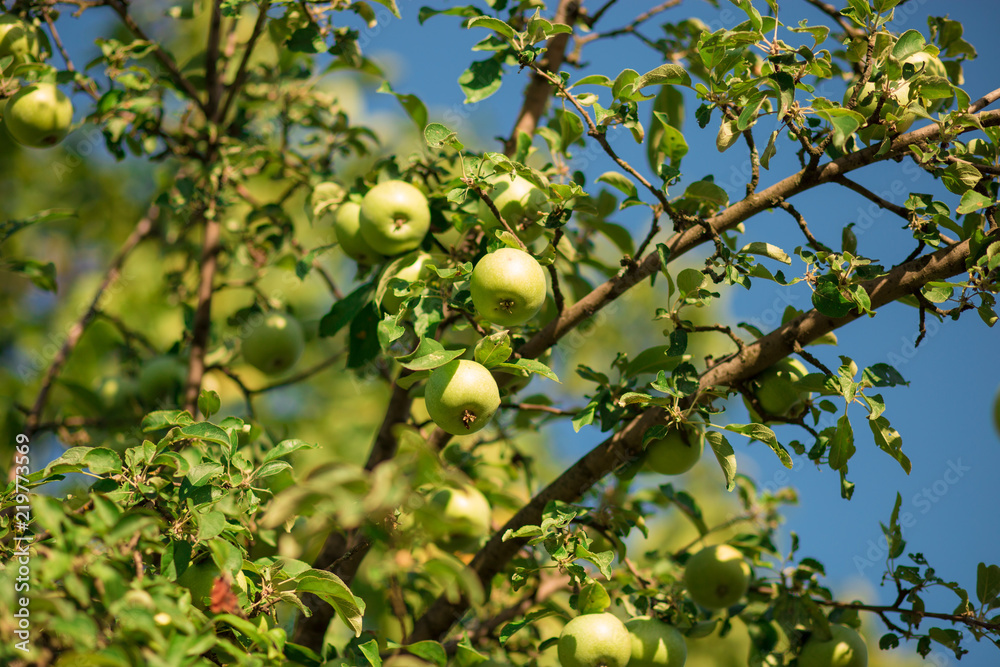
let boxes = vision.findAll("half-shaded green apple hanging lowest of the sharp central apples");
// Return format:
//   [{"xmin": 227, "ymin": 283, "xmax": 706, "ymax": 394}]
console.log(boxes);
[{"xmin": 424, "ymin": 359, "xmax": 500, "ymax": 435}]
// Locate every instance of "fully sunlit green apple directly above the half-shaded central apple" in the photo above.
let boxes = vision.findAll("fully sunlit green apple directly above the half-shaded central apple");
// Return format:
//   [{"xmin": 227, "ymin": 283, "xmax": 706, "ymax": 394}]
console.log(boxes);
[{"xmin": 469, "ymin": 248, "xmax": 545, "ymax": 327}]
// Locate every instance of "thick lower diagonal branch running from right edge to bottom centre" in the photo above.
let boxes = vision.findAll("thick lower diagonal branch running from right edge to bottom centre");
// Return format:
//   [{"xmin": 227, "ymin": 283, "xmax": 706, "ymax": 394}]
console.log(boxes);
[{"xmin": 410, "ymin": 228, "xmax": 1000, "ymax": 642}]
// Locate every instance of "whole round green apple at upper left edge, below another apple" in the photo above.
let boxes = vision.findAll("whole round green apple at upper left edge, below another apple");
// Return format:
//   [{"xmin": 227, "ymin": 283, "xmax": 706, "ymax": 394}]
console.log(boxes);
[{"xmin": 3, "ymin": 83, "xmax": 73, "ymax": 148}]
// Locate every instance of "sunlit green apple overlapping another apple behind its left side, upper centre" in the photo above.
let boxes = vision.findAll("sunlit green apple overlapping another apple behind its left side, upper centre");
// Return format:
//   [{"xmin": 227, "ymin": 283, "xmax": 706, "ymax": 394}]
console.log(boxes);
[{"xmin": 360, "ymin": 181, "xmax": 431, "ymax": 256}]
